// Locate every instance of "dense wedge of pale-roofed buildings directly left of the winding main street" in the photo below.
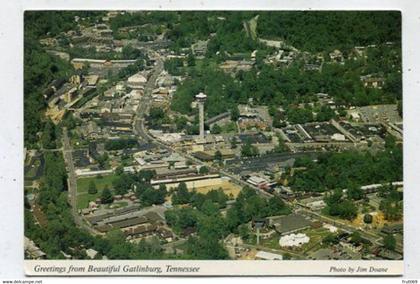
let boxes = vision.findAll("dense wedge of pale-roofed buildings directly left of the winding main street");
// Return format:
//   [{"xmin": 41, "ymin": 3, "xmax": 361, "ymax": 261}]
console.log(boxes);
[{"xmin": 68, "ymin": 71, "xmax": 153, "ymax": 176}]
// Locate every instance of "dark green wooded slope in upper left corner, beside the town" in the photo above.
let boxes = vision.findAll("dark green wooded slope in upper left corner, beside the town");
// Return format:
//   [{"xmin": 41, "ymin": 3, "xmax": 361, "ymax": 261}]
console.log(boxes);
[{"xmin": 24, "ymin": 11, "xmax": 105, "ymax": 146}]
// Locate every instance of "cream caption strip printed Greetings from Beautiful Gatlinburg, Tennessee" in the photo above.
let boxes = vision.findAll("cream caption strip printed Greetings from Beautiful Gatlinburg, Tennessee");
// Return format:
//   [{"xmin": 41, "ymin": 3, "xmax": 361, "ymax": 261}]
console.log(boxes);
[{"xmin": 24, "ymin": 260, "xmax": 404, "ymax": 276}]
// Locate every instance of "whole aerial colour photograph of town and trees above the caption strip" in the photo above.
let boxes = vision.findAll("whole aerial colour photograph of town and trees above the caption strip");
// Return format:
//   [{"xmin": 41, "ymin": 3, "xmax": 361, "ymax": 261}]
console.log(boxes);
[{"xmin": 23, "ymin": 10, "xmax": 404, "ymax": 263}]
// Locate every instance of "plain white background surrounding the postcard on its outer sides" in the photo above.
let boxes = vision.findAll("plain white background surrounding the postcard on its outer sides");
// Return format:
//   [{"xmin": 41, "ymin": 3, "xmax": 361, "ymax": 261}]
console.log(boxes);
[{"xmin": 0, "ymin": 0, "xmax": 420, "ymax": 277}]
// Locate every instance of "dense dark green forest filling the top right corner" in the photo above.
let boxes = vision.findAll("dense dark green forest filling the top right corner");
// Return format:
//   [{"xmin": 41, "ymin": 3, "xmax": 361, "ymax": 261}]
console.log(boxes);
[{"xmin": 257, "ymin": 11, "xmax": 401, "ymax": 52}]
